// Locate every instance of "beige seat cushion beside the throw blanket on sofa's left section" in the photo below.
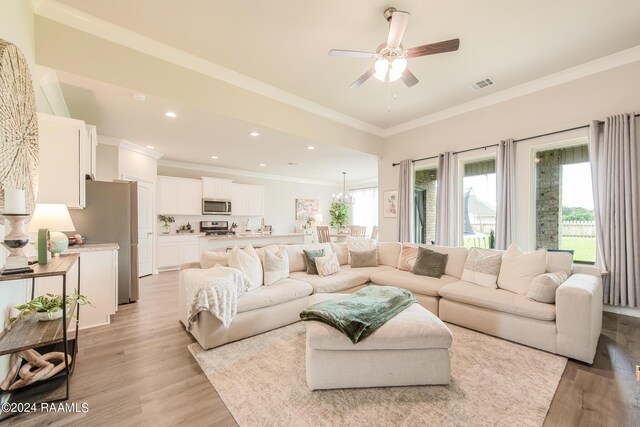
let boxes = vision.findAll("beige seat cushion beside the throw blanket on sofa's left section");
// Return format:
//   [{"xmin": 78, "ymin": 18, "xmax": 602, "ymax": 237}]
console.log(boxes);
[{"xmin": 238, "ymin": 279, "xmax": 313, "ymax": 313}]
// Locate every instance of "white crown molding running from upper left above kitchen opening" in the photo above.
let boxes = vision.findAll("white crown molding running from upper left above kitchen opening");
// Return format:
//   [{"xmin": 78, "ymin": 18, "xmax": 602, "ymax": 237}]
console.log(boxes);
[{"xmin": 31, "ymin": 0, "xmax": 383, "ymax": 136}]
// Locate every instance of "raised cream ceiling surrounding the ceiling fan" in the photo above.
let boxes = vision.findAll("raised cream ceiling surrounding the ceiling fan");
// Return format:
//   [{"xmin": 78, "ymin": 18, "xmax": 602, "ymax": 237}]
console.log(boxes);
[{"xmin": 53, "ymin": 0, "xmax": 640, "ymax": 128}]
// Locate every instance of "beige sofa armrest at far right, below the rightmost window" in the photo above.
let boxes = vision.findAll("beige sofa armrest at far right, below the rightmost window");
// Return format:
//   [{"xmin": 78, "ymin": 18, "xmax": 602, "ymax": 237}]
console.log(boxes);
[{"xmin": 556, "ymin": 273, "xmax": 602, "ymax": 363}]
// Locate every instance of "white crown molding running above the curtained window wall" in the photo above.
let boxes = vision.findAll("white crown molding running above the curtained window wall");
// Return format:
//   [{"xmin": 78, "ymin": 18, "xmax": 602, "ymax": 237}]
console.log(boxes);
[{"xmin": 381, "ymin": 46, "xmax": 640, "ymax": 138}]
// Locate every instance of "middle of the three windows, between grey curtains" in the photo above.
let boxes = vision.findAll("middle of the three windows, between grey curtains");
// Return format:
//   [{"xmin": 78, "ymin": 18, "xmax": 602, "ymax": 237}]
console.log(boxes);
[{"xmin": 462, "ymin": 159, "xmax": 496, "ymax": 248}]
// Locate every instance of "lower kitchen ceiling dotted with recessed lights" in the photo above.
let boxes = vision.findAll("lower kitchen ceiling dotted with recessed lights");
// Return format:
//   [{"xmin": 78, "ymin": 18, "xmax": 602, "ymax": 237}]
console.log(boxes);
[{"xmin": 57, "ymin": 71, "xmax": 378, "ymax": 184}]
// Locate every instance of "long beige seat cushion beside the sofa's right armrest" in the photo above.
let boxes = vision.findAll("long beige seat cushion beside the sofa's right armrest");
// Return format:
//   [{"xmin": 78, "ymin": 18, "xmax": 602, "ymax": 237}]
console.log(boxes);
[{"xmin": 439, "ymin": 281, "xmax": 556, "ymax": 320}]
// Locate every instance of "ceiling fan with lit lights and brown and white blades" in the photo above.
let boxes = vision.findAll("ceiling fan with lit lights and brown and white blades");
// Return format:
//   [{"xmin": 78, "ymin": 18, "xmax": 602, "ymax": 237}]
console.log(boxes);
[{"xmin": 329, "ymin": 7, "xmax": 460, "ymax": 89}]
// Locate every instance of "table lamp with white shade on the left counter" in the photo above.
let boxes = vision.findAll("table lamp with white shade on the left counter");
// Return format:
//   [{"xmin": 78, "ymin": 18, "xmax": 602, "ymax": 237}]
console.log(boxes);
[{"xmin": 29, "ymin": 203, "xmax": 76, "ymax": 265}]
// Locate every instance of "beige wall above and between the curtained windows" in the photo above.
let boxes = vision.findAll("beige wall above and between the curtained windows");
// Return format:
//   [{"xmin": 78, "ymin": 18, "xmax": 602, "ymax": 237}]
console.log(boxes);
[{"xmin": 378, "ymin": 62, "xmax": 640, "ymax": 248}]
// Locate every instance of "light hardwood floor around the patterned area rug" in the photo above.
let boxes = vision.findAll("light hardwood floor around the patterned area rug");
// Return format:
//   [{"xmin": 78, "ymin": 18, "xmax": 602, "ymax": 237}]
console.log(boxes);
[{"xmin": 8, "ymin": 273, "xmax": 640, "ymax": 426}]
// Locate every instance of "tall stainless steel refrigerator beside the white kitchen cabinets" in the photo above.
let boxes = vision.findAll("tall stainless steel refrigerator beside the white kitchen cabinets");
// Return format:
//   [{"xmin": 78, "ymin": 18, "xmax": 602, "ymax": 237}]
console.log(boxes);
[{"xmin": 69, "ymin": 181, "xmax": 138, "ymax": 304}]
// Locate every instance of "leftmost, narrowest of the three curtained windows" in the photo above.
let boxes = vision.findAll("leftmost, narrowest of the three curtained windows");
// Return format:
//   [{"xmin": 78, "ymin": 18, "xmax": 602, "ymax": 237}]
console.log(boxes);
[{"xmin": 413, "ymin": 166, "xmax": 438, "ymax": 243}]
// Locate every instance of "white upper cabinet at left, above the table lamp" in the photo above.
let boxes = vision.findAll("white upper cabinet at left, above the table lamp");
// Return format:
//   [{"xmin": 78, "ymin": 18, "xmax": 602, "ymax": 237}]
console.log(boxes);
[{"xmin": 37, "ymin": 113, "xmax": 95, "ymax": 209}]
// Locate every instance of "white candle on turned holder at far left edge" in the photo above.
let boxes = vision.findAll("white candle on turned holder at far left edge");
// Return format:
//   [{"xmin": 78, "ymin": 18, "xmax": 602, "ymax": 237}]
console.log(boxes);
[{"xmin": 2, "ymin": 189, "xmax": 33, "ymax": 275}]
